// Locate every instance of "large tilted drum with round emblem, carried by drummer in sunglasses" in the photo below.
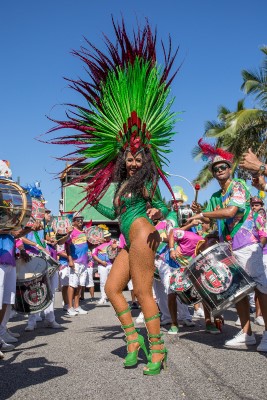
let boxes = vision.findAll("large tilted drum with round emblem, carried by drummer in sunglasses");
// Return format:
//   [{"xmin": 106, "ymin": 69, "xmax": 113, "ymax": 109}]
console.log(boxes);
[{"xmin": 186, "ymin": 243, "xmax": 256, "ymax": 315}]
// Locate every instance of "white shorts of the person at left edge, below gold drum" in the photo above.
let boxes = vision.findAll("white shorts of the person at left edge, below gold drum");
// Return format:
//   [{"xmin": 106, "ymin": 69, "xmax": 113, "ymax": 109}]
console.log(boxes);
[{"xmin": 0, "ymin": 264, "xmax": 16, "ymax": 309}]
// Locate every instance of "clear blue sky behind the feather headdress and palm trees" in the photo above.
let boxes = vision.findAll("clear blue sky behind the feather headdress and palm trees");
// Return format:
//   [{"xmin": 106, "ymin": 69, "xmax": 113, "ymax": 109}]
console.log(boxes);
[{"xmin": 0, "ymin": 0, "xmax": 267, "ymax": 214}]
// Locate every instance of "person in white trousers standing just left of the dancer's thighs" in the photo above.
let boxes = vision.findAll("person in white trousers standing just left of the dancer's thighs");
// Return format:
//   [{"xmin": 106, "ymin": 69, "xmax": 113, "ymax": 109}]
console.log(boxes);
[{"xmin": 92, "ymin": 230, "xmax": 115, "ymax": 305}]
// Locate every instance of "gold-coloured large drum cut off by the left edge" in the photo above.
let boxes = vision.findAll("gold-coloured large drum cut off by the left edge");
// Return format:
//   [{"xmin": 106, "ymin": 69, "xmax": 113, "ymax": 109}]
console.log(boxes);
[{"xmin": 0, "ymin": 179, "xmax": 32, "ymax": 230}]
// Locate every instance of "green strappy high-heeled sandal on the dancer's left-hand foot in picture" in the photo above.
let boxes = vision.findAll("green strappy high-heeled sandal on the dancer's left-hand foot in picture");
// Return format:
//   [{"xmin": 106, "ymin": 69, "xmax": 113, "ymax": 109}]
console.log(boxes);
[{"xmin": 117, "ymin": 308, "xmax": 149, "ymax": 368}]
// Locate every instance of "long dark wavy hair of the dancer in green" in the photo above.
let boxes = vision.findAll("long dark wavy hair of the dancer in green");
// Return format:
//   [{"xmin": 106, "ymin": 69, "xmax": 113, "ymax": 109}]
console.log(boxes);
[{"xmin": 113, "ymin": 149, "xmax": 158, "ymax": 196}]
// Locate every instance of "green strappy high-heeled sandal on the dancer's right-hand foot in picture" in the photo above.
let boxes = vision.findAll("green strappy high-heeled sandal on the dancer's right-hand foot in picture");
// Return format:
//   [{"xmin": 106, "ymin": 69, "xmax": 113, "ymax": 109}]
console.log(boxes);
[{"xmin": 143, "ymin": 314, "xmax": 168, "ymax": 375}]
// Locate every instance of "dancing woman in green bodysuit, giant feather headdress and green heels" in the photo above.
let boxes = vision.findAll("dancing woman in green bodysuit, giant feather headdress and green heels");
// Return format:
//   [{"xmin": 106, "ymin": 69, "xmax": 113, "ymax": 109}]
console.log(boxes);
[{"xmin": 49, "ymin": 21, "xmax": 181, "ymax": 375}]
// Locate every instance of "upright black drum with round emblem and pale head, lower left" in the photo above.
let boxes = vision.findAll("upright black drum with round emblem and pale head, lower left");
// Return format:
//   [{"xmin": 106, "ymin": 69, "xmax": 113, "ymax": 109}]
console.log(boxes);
[{"xmin": 14, "ymin": 256, "xmax": 53, "ymax": 314}]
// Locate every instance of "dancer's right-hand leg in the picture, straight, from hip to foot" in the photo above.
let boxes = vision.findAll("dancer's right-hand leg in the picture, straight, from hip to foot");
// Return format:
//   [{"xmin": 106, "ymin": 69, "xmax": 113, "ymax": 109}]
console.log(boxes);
[{"xmin": 129, "ymin": 219, "xmax": 165, "ymax": 369}]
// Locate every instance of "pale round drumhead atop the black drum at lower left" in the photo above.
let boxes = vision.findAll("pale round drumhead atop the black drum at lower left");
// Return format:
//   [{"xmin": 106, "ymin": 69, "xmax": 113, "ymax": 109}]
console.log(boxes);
[{"xmin": 16, "ymin": 256, "xmax": 47, "ymax": 281}]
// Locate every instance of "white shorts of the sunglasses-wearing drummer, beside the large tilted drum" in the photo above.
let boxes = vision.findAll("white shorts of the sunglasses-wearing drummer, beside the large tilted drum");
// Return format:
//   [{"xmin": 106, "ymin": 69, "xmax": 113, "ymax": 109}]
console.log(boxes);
[{"xmin": 233, "ymin": 243, "xmax": 267, "ymax": 294}]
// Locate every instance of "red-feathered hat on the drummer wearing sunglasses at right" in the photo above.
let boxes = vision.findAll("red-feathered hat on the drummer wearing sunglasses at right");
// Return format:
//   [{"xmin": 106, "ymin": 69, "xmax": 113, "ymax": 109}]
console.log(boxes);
[{"xmin": 198, "ymin": 138, "xmax": 234, "ymax": 168}]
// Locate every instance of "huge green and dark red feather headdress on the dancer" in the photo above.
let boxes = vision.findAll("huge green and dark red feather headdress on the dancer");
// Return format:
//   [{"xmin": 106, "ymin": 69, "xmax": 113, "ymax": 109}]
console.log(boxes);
[{"xmin": 50, "ymin": 19, "xmax": 182, "ymax": 205}]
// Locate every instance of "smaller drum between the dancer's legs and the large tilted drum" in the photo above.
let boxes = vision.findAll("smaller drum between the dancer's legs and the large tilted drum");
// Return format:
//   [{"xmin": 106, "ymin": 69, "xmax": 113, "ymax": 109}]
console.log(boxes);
[{"xmin": 170, "ymin": 267, "xmax": 201, "ymax": 305}]
